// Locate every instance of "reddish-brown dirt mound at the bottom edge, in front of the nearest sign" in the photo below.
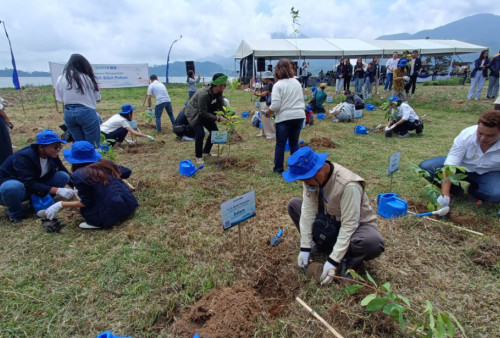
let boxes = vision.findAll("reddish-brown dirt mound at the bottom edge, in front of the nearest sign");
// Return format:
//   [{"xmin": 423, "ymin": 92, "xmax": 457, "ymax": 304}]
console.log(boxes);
[{"xmin": 174, "ymin": 285, "xmax": 263, "ymax": 337}]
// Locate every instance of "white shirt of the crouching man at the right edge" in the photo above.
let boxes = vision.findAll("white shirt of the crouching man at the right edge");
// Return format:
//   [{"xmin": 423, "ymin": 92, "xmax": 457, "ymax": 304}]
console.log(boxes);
[{"xmin": 444, "ymin": 125, "xmax": 500, "ymax": 175}]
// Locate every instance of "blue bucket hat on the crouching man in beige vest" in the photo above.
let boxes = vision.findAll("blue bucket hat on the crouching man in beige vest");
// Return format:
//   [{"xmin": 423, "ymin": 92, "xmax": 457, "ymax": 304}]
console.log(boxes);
[{"xmin": 281, "ymin": 147, "xmax": 328, "ymax": 182}]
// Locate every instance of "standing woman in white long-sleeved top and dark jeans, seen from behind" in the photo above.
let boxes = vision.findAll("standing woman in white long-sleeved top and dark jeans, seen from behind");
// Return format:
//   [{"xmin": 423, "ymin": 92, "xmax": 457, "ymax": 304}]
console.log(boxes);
[{"xmin": 265, "ymin": 59, "xmax": 306, "ymax": 173}]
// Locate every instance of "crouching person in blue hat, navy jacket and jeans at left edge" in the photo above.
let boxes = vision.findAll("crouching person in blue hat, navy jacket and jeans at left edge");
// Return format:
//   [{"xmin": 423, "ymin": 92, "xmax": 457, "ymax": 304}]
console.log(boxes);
[{"xmin": 0, "ymin": 129, "xmax": 75, "ymax": 223}]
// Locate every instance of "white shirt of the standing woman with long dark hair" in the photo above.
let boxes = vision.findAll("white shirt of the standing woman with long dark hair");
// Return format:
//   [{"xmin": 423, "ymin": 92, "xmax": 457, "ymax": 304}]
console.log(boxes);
[{"xmin": 55, "ymin": 74, "xmax": 101, "ymax": 109}]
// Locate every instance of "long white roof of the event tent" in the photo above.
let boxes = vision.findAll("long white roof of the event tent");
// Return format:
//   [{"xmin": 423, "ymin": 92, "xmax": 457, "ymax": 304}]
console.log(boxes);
[{"xmin": 234, "ymin": 38, "xmax": 486, "ymax": 59}]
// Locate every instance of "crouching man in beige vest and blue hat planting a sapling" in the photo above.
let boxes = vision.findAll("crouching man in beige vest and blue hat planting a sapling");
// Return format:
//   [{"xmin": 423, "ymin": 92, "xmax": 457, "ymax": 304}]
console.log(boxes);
[{"xmin": 282, "ymin": 147, "xmax": 385, "ymax": 284}]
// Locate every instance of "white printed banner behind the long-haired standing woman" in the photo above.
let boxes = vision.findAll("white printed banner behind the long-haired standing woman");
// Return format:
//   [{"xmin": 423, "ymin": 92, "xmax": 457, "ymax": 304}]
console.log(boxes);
[{"xmin": 49, "ymin": 62, "xmax": 149, "ymax": 88}]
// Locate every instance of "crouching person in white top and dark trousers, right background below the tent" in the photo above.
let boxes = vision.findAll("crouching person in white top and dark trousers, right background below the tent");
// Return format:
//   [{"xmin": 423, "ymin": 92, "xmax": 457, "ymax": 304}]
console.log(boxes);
[{"xmin": 385, "ymin": 95, "xmax": 424, "ymax": 137}]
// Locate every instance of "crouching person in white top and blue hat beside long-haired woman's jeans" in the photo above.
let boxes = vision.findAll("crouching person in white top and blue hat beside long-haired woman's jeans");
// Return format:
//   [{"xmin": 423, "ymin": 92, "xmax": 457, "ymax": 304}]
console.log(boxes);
[{"xmin": 101, "ymin": 104, "xmax": 155, "ymax": 149}]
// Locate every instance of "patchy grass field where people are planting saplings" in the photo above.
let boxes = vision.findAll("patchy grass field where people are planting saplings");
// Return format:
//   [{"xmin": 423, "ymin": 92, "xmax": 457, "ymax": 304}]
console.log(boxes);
[{"xmin": 0, "ymin": 81, "xmax": 500, "ymax": 337}]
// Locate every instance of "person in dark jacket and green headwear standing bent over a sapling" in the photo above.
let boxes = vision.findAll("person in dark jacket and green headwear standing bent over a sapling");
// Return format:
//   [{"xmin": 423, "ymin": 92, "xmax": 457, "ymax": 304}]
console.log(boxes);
[{"xmin": 184, "ymin": 73, "xmax": 227, "ymax": 164}]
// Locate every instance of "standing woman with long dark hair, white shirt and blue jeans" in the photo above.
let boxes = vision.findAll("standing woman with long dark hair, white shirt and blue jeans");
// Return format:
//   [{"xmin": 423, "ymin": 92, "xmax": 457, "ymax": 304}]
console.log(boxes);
[{"xmin": 55, "ymin": 54, "xmax": 101, "ymax": 148}]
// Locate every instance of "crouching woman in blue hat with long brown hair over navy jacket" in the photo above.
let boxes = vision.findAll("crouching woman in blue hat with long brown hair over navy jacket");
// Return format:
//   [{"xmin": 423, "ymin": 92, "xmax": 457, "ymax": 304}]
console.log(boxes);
[{"xmin": 40, "ymin": 141, "xmax": 139, "ymax": 229}]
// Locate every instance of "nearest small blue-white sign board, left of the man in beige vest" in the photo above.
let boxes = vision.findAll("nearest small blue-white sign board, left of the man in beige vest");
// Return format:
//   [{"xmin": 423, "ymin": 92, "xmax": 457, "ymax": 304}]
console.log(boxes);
[{"xmin": 220, "ymin": 190, "xmax": 256, "ymax": 230}]
